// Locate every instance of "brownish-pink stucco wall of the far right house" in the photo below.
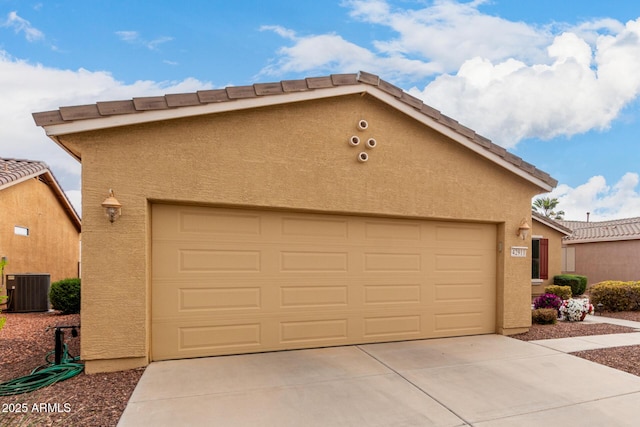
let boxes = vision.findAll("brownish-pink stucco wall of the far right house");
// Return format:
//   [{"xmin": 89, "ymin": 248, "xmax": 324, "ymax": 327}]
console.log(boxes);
[{"xmin": 570, "ymin": 240, "xmax": 640, "ymax": 285}]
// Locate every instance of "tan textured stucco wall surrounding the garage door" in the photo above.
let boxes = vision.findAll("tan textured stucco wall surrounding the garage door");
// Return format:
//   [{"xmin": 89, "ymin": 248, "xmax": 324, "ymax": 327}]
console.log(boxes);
[{"xmin": 61, "ymin": 95, "xmax": 540, "ymax": 372}]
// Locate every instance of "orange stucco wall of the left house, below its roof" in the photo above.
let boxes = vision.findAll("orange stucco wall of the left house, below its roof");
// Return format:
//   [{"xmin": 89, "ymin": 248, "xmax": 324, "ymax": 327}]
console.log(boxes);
[{"xmin": 0, "ymin": 178, "xmax": 80, "ymax": 282}]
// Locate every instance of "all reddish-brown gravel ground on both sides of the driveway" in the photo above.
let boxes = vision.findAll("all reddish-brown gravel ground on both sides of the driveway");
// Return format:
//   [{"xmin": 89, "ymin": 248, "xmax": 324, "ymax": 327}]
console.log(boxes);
[{"xmin": 0, "ymin": 312, "xmax": 640, "ymax": 427}]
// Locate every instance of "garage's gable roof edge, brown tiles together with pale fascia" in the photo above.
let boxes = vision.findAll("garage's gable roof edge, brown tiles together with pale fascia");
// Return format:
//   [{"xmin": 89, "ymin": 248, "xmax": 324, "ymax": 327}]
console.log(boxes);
[{"xmin": 33, "ymin": 71, "xmax": 557, "ymax": 191}]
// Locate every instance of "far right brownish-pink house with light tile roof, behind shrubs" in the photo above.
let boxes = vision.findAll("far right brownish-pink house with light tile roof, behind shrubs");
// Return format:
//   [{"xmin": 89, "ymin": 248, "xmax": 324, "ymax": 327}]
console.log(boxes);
[{"xmin": 561, "ymin": 217, "xmax": 640, "ymax": 285}]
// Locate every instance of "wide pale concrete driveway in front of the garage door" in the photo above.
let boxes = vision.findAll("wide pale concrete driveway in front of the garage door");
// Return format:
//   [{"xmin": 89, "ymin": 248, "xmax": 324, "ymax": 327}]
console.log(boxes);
[{"xmin": 118, "ymin": 335, "xmax": 640, "ymax": 427}]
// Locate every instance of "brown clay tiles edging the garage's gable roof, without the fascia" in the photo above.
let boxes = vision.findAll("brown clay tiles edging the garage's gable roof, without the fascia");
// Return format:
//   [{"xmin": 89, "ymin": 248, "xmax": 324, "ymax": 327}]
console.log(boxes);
[{"xmin": 33, "ymin": 71, "xmax": 558, "ymax": 188}]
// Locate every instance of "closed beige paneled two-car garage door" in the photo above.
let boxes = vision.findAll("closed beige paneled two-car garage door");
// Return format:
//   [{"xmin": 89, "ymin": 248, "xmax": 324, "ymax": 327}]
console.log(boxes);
[{"xmin": 151, "ymin": 205, "xmax": 496, "ymax": 360}]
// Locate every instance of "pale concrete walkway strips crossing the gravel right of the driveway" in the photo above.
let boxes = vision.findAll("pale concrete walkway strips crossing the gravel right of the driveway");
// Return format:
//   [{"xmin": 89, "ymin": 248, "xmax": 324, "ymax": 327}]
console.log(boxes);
[{"xmin": 529, "ymin": 316, "xmax": 640, "ymax": 353}]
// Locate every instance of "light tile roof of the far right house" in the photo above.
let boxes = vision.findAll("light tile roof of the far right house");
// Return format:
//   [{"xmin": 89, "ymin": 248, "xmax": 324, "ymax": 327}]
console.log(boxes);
[{"xmin": 560, "ymin": 217, "xmax": 640, "ymax": 244}]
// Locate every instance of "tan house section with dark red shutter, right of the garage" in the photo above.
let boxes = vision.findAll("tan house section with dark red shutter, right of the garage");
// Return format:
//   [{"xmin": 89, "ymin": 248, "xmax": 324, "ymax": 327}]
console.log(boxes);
[{"xmin": 531, "ymin": 211, "xmax": 571, "ymax": 297}]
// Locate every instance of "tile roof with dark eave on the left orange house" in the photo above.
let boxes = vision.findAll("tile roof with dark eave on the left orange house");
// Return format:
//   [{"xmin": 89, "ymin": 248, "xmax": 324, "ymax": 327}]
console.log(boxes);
[{"xmin": 0, "ymin": 158, "xmax": 81, "ymax": 231}]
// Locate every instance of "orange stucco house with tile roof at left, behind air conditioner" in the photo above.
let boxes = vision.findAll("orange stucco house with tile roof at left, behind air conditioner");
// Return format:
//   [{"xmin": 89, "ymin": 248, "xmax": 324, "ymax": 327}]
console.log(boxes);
[{"xmin": 0, "ymin": 158, "xmax": 80, "ymax": 283}]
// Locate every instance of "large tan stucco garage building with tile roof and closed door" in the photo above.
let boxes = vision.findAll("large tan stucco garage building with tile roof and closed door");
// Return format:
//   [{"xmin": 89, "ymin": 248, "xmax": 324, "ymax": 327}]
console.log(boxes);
[{"xmin": 34, "ymin": 72, "xmax": 557, "ymax": 373}]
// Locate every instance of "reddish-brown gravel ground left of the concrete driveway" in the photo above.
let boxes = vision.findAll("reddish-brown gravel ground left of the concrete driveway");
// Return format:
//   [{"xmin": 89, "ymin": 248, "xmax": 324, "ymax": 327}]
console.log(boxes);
[{"xmin": 0, "ymin": 313, "xmax": 144, "ymax": 426}]
